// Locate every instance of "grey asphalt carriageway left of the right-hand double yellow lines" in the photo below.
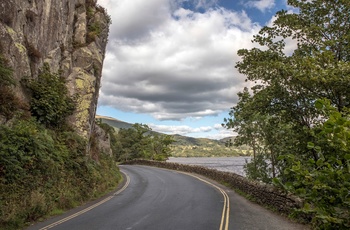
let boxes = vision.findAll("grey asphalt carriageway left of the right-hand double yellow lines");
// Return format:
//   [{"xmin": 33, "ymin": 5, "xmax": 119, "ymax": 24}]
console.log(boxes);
[{"xmin": 30, "ymin": 166, "xmax": 224, "ymax": 230}]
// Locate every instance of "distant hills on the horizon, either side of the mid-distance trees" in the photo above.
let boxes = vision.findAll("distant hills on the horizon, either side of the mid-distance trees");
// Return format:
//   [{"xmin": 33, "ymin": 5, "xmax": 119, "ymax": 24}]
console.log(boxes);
[{"xmin": 96, "ymin": 115, "xmax": 250, "ymax": 157}]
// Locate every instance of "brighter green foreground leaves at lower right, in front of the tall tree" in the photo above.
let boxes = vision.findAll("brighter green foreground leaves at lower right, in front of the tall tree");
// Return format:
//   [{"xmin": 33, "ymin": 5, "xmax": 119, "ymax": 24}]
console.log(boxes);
[{"xmin": 283, "ymin": 100, "xmax": 350, "ymax": 229}]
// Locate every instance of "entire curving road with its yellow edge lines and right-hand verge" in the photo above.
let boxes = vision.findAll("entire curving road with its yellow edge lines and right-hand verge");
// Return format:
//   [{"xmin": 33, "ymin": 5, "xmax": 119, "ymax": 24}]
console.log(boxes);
[{"xmin": 28, "ymin": 165, "xmax": 306, "ymax": 230}]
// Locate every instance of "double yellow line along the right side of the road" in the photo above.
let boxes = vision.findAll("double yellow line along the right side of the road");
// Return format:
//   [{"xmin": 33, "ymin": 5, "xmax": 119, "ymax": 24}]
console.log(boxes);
[{"xmin": 177, "ymin": 171, "xmax": 230, "ymax": 230}]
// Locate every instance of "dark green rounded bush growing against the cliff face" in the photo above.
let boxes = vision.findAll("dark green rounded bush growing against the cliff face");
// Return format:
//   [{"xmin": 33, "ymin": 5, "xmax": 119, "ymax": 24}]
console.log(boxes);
[{"xmin": 25, "ymin": 64, "xmax": 75, "ymax": 128}]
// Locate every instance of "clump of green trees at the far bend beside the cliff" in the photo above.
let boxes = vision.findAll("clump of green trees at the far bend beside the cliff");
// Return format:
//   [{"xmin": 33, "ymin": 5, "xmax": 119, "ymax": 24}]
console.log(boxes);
[{"xmin": 116, "ymin": 123, "xmax": 174, "ymax": 161}]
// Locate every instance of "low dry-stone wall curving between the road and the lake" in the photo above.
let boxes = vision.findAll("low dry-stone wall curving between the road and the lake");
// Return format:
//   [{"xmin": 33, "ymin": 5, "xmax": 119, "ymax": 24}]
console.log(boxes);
[{"xmin": 124, "ymin": 160, "xmax": 303, "ymax": 215}]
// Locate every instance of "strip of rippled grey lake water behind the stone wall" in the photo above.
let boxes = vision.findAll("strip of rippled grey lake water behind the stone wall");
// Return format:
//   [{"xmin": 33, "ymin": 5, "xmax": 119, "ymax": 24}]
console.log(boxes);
[{"xmin": 167, "ymin": 157, "xmax": 251, "ymax": 176}]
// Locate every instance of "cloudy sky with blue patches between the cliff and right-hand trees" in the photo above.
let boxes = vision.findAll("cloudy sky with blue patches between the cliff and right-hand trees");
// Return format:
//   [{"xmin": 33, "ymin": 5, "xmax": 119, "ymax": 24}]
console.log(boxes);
[{"xmin": 97, "ymin": 0, "xmax": 287, "ymax": 139}]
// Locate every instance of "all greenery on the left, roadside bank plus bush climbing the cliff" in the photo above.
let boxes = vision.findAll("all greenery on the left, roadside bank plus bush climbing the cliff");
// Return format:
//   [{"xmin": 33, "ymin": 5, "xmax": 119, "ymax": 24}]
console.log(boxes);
[{"xmin": 0, "ymin": 59, "xmax": 121, "ymax": 229}]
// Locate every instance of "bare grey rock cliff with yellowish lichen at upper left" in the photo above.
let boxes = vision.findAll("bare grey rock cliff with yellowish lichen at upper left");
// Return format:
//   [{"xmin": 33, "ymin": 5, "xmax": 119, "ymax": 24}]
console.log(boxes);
[{"xmin": 0, "ymin": 0, "xmax": 110, "ymax": 138}]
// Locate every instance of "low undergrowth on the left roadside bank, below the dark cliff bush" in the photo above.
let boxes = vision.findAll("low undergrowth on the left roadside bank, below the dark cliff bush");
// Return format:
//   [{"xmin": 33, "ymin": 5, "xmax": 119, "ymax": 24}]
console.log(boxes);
[{"xmin": 0, "ymin": 119, "xmax": 120, "ymax": 229}]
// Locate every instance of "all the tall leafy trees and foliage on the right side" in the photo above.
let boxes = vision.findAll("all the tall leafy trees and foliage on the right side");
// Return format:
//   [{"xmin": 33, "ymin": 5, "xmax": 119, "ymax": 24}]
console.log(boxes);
[{"xmin": 224, "ymin": 0, "xmax": 350, "ymax": 229}]
